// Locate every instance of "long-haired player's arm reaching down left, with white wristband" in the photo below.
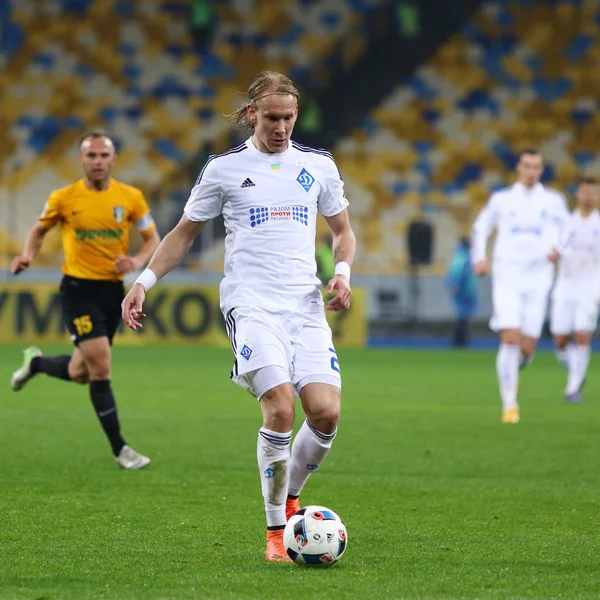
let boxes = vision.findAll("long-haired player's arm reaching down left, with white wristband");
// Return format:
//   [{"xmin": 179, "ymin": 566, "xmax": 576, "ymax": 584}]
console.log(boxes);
[{"xmin": 121, "ymin": 215, "xmax": 205, "ymax": 331}]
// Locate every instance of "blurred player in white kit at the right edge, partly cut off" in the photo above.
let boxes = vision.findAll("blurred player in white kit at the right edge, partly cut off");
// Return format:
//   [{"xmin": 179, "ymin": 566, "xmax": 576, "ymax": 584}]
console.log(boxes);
[{"xmin": 550, "ymin": 178, "xmax": 600, "ymax": 403}]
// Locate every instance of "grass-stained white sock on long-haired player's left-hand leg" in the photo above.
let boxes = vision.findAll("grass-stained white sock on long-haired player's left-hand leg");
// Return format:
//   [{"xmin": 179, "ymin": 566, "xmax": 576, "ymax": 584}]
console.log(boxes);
[{"xmin": 256, "ymin": 427, "xmax": 292, "ymax": 527}]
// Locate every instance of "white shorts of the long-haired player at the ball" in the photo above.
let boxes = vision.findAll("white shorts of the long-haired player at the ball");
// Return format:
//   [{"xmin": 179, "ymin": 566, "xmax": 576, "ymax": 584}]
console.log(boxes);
[{"xmin": 225, "ymin": 308, "xmax": 342, "ymax": 399}]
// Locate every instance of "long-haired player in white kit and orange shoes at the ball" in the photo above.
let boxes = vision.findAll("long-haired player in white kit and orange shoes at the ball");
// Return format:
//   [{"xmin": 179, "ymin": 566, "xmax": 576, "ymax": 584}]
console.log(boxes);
[{"xmin": 123, "ymin": 72, "xmax": 356, "ymax": 562}]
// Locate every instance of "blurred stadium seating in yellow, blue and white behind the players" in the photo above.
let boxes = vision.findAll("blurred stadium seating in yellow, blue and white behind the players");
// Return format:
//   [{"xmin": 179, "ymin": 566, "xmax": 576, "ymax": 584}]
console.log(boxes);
[{"xmin": 0, "ymin": 0, "xmax": 600, "ymax": 273}]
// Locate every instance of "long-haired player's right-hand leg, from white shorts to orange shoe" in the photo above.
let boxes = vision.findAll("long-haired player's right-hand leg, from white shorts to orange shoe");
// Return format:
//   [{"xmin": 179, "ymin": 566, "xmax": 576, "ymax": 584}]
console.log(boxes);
[{"xmin": 286, "ymin": 314, "xmax": 341, "ymax": 510}]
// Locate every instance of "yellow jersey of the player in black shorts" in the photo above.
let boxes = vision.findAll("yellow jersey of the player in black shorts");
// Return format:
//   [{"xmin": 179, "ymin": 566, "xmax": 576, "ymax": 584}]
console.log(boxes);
[{"xmin": 40, "ymin": 179, "xmax": 155, "ymax": 281}]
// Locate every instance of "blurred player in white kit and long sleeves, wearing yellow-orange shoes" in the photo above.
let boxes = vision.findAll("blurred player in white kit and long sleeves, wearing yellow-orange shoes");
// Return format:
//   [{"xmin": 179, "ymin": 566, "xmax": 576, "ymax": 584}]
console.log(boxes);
[{"xmin": 472, "ymin": 150, "xmax": 570, "ymax": 423}]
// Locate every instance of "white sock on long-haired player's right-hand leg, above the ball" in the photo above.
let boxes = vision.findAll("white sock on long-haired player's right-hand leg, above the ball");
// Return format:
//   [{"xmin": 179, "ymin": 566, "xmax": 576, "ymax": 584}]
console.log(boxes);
[{"xmin": 288, "ymin": 419, "xmax": 337, "ymax": 496}]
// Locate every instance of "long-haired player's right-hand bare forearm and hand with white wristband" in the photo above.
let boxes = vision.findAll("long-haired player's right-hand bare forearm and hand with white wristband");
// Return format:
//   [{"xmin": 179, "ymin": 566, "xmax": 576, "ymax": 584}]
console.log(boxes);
[{"xmin": 325, "ymin": 210, "xmax": 356, "ymax": 312}]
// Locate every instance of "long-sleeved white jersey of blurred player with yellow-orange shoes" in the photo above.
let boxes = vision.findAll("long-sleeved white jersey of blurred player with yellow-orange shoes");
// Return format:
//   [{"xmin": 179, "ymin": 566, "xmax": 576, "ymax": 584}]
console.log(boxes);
[{"xmin": 472, "ymin": 183, "xmax": 570, "ymax": 271}]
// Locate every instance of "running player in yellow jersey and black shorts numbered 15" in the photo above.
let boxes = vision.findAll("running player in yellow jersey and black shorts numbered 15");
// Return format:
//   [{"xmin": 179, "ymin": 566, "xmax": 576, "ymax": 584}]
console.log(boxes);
[{"xmin": 11, "ymin": 131, "xmax": 160, "ymax": 469}]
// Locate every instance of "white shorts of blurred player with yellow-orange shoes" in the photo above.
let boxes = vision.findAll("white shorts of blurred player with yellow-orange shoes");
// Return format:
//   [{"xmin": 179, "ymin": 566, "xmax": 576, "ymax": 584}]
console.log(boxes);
[{"xmin": 490, "ymin": 283, "xmax": 548, "ymax": 339}]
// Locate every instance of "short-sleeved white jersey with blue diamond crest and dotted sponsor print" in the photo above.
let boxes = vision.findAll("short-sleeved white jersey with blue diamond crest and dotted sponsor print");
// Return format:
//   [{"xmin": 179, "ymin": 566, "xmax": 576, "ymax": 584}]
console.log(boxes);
[{"xmin": 184, "ymin": 138, "xmax": 348, "ymax": 313}]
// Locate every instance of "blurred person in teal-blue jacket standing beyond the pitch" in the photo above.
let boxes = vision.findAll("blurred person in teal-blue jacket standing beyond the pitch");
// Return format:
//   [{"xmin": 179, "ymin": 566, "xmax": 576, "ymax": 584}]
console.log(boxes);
[{"xmin": 446, "ymin": 238, "xmax": 477, "ymax": 348}]
